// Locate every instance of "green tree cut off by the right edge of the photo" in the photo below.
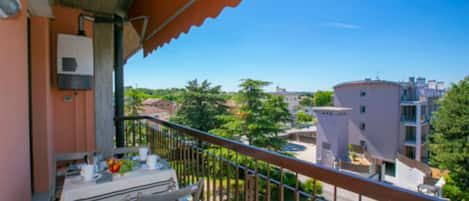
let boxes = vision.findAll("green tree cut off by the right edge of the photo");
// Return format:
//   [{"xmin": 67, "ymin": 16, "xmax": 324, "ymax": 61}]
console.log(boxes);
[{"xmin": 429, "ymin": 76, "xmax": 469, "ymax": 200}]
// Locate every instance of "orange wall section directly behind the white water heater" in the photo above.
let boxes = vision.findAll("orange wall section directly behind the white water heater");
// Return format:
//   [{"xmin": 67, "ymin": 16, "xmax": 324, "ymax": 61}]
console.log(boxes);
[{"xmin": 50, "ymin": 6, "xmax": 96, "ymax": 153}]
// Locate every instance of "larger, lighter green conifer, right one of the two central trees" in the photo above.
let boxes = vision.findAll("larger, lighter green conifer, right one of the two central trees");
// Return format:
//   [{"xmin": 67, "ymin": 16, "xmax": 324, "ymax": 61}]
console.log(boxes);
[{"xmin": 211, "ymin": 79, "xmax": 290, "ymax": 151}]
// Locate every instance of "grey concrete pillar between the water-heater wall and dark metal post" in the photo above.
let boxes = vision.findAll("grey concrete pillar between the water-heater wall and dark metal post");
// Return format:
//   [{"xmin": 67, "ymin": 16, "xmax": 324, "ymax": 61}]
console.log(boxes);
[{"xmin": 93, "ymin": 23, "xmax": 115, "ymax": 157}]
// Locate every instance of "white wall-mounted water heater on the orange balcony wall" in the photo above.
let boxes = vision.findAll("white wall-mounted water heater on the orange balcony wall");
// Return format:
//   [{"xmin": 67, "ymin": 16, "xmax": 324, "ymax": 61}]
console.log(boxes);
[{"xmin": 57, "ymin": 34, "xmax": 93, "ymax": 90}]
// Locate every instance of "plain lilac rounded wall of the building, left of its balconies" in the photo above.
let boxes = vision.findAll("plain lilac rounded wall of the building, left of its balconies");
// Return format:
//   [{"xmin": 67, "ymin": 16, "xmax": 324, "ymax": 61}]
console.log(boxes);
[{"xmin": 334, "ymin": 82, "xmax": 401, "ymax": 161}]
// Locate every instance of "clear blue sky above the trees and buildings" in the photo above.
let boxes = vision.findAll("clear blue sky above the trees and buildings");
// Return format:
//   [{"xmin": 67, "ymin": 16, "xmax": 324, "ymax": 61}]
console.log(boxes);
[{"xmin": 125, "ymin": 0, "xmax": 469, "ymax": 91}]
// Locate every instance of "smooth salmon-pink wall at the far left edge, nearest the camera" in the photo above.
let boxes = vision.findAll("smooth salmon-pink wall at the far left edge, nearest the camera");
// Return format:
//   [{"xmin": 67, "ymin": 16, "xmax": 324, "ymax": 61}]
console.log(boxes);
[{"xmin": 0, "ymin": 0, "xmax": 31, "ymax": 201}]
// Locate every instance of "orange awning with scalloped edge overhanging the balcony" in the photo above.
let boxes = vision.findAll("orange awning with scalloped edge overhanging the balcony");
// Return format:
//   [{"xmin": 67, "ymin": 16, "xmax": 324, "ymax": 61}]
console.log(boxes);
[{"xmin": 128, "ymin": 0, "xmax": 241, "ymax": 56}]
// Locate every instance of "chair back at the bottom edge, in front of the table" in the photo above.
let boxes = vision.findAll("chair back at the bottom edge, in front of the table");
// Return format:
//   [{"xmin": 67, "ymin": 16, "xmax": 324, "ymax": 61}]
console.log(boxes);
[{"xmin": 137, "ymin": 180, "xmax": 204, "ymax": 201}]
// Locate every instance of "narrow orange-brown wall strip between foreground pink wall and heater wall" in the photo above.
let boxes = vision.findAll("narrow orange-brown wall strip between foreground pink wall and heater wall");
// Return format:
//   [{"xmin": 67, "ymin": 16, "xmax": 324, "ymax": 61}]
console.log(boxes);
[{"xmin": 30, "ymin": 16, "xmax": 54, "ymax": 192}]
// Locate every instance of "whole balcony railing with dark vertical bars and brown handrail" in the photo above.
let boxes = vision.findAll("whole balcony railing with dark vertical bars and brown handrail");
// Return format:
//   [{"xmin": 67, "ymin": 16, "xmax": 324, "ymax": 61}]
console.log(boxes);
[{"xmin": 122, "ymin": 116, "xmax": 438, "ymax": 201}]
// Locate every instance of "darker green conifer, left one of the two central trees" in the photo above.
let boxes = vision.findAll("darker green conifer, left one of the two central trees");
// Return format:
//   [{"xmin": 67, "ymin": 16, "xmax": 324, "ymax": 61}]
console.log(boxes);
[{"xmin": 172, "ymin": 80, "xmax": 228, "ymax": 131}]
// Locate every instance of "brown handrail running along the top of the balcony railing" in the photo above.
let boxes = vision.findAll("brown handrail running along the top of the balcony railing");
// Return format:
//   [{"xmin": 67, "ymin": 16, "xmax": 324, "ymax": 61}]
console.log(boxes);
[{"xmin": 118, "ymin": 116, "xmax": 441, "ymax": 201}]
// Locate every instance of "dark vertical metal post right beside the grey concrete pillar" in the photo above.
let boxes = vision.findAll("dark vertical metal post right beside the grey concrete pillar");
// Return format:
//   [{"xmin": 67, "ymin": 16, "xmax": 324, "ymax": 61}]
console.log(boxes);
[{"xmin": 114, "ymin": 15, "xmax": 125, "ymax": 147}]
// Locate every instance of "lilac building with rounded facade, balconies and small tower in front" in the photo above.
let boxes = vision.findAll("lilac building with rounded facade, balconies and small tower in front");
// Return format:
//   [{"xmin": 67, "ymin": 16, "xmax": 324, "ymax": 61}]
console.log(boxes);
[{"xmin": 314, "ymin": 77, "xmax": 445, "ymax": 193}]
